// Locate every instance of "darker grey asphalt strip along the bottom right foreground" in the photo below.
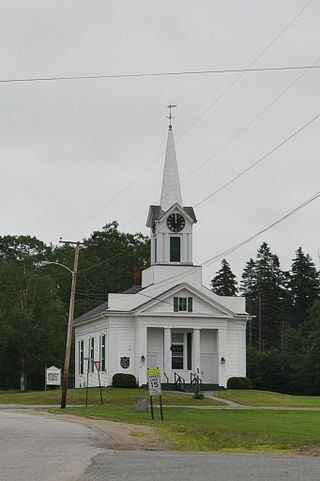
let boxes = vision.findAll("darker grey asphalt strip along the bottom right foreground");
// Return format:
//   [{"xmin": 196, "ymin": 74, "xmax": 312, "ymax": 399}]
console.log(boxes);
[{"xmin": 81, "ymin": 451, "xmax": 320, "ymax": 481}]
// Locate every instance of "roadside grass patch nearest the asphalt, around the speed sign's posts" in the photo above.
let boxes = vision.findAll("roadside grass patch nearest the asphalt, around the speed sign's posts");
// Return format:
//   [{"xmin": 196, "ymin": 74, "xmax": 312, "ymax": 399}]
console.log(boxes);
[{"xmin": 51, "ymin": 406, "xmax": 320, "ymax": 453}]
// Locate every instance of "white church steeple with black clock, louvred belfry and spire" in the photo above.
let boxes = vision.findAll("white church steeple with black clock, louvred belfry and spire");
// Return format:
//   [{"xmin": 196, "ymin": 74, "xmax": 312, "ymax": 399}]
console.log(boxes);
[{"xmin": 146, "ymin": 123, "xmax": 197, "ymax": 266}]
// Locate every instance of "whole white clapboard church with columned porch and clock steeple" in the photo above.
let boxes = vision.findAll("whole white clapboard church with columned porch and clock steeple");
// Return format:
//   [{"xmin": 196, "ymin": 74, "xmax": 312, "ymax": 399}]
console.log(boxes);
[{"xmin": 74, "ymin": 124, "xmax": 249, "ymax": 387}]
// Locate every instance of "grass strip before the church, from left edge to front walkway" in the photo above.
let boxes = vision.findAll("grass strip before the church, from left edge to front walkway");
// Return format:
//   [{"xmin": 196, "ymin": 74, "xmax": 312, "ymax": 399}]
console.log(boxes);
[{"xmin": 0, "ymin": 387, "xmax": 222, "ymax": 407}]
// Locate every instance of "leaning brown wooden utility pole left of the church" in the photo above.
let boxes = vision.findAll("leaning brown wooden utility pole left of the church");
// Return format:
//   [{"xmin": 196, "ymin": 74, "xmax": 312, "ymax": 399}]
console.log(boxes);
[{"xmin": 59, "ymin": 239, "xmax": 81, "ymax": 409}]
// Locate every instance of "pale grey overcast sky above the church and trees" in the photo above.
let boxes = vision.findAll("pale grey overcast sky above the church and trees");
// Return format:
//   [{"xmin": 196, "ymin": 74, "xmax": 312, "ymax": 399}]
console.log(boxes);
[{"xmin": 0, "ymin": 0, "xmax": 320, "ymax": 284}]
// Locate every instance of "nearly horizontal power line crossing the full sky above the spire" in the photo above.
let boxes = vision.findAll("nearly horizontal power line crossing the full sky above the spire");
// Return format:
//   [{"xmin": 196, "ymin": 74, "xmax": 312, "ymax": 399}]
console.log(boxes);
[{"xmin": 0, "ymin": 65, "xmax": 320, "ymax": 84}]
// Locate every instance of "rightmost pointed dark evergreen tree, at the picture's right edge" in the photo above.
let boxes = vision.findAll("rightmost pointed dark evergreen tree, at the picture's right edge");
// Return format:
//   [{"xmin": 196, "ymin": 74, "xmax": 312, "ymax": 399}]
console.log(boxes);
[{"xmin": 289, "ymin": 247, "xmax": 320, "ymax": 327}]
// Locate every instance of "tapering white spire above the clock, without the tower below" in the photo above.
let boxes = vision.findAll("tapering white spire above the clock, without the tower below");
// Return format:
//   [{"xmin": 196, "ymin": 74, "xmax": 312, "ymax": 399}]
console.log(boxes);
[{"xmin": 160, "ymin": 125, "xmax": 182, "ymax": 211}]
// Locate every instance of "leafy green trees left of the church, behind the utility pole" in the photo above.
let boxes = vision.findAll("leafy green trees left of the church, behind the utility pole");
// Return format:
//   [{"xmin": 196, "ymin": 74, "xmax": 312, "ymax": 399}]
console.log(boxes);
[{"xmin": 0, "ymin": 222, "xmax": 150, "ymax": 389}]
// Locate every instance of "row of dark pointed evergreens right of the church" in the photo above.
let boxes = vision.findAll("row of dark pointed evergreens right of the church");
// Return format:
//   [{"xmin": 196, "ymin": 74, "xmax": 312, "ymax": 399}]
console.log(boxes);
[{"xmin": 211, "ymin": 242, "xmax": 320, "ymax": 394}]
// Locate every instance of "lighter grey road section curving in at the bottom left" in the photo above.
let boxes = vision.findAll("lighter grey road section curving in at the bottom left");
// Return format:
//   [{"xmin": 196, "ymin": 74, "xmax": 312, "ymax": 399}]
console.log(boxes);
[{"xmin": 0, "ymin": 411, "xmax": 101, "ymax": 481}]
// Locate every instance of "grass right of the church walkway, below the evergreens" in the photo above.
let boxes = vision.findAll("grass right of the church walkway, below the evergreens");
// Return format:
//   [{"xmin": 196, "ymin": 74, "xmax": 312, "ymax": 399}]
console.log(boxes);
[{"xmin": 214, "ymin": 389, "xmax": 320, "ymax": 408}]
